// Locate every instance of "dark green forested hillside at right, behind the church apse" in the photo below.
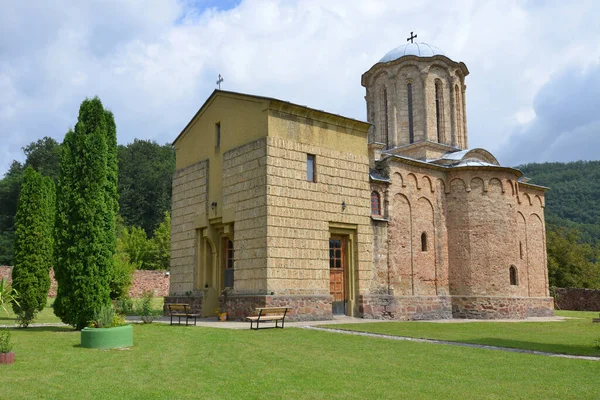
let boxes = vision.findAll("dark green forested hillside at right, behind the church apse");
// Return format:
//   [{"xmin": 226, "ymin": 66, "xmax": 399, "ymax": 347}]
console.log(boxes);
[{"xmin": 517, "ymin": 161, "xmax": 600, "ymax": 244}]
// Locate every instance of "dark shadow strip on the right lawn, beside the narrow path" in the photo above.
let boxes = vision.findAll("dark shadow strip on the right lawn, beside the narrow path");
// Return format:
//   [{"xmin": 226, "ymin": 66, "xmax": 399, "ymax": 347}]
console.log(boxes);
[{"xmin": 455, "ymin": 338, "xmax": 600, "ymax": 357}]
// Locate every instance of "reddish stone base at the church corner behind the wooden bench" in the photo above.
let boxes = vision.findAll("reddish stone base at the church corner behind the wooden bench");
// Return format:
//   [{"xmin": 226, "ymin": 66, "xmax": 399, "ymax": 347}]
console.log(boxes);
[{"xmin": 222, "ymin": 295, "xmax": 333, "ymax": 321}]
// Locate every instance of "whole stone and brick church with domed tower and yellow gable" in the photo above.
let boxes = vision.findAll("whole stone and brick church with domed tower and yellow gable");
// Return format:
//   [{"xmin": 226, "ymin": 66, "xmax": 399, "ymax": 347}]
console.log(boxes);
[{"xmin": 165, "ymin": 42, "xmax": 553, "ymax": 320}]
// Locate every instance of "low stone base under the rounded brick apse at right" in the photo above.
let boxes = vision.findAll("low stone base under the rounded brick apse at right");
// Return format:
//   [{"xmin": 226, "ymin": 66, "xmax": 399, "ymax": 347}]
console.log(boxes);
[{"xmin": 452, "ymin": 296, "xmax": 554, "ymax": 319}]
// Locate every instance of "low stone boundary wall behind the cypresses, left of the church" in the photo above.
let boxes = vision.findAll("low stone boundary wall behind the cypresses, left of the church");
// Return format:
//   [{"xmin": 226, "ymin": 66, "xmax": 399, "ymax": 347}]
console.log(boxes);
[{"xmin": 0, "ymin": 266, "xmax": 169, "ymax": 297}]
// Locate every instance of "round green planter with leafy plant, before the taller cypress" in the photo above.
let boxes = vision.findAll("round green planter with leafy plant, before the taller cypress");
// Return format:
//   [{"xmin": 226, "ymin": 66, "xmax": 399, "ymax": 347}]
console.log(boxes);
[{"xmin": 81, "ymin": 306, "xmax": 133, "ymax": 349}]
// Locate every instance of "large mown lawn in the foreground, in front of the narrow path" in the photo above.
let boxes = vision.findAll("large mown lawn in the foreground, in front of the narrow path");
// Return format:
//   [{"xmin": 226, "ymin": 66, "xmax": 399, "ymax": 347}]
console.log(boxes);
[{"xmin": 0, "ymin": 324, "xmax": 600, "ymax": 399}]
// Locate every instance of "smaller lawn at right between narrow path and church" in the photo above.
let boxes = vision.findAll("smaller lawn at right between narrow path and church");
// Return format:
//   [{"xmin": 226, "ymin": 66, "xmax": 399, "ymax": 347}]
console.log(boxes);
[{"xmin": 329, "ymin": 311, "xmax": 600, "ymax": 356}]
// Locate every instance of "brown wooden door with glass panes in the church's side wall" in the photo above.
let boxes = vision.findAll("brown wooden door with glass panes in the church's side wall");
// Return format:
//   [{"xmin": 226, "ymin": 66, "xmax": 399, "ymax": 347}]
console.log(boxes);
[{"xmin": 329, "ymin": 235, "xmax": 348, "ymax": 315}]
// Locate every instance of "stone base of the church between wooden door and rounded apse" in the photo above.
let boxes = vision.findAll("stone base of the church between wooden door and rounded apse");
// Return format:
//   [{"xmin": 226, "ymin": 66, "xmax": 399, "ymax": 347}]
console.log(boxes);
[{"xmin": 358, "ymin": 294, "xmax": 452, "ymax": 320}]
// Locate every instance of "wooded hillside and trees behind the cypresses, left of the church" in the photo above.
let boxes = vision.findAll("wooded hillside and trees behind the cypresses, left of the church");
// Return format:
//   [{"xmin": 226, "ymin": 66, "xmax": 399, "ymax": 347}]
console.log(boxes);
[{"xmin": 0, "ymin": 137, "xmax": 175, "ymax": 269}]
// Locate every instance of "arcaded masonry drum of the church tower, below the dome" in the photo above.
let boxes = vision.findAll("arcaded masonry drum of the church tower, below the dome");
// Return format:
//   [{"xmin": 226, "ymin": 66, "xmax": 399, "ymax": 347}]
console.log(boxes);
[{"xmin": 363, "ymin": 58, "xmax": 468, "ymax": 149}]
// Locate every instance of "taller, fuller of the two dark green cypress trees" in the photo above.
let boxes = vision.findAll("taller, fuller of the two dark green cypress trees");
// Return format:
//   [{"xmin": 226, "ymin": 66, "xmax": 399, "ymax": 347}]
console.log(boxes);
[{"xmin": 54, "ymin": 97, "xmax": 116, "ymax": 329}]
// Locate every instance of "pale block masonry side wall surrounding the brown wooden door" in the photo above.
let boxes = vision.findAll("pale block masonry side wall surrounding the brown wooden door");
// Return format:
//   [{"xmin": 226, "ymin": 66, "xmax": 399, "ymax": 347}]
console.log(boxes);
[{"xmin": 267, "ymin": 137, "xmax": 373, "ymax": 296}]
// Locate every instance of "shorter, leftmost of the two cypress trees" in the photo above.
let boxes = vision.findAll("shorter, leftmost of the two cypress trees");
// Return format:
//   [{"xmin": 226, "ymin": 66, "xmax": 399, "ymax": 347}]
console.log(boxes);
[{"xmin": 12, "ymin": 167, "xmax": 54, "ymax": 327}]
